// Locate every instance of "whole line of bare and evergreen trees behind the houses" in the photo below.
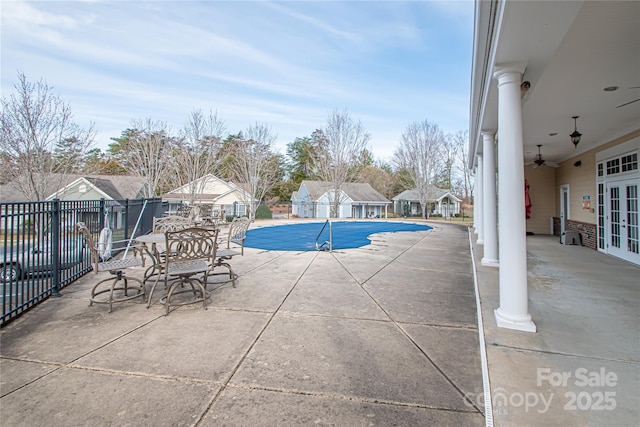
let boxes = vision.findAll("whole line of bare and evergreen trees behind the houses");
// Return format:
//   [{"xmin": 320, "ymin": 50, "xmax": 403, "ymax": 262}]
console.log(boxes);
[{"xmin": 0, "ymin": 72, "xmax": 473, "ymax": 214}]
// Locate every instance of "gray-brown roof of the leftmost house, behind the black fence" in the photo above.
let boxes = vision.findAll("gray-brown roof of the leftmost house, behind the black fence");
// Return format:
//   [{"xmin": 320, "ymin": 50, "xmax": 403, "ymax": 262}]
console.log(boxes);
[{"xmin": 0, "ymin": 173, "xmax": 147, "ymax": 202}]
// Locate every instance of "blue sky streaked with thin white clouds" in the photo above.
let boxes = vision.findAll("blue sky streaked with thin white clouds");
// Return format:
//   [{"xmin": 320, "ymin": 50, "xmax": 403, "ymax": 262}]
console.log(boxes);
[{"xmin": 0, "ymin": 0, "xmax": 474, "ymax": 162}]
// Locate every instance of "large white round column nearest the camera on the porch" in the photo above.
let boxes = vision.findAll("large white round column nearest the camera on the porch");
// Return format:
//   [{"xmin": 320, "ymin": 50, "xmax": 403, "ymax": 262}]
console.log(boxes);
[{"xmin": 494, "ymin": 64, "xmax": 536, "ymax": 332}]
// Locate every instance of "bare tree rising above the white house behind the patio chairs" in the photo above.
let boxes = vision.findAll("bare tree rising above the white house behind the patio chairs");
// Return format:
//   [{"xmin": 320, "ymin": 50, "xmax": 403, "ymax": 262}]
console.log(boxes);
[{"xmin": 171, "ymin": 110, "xmax": 226, "ymax": 205}]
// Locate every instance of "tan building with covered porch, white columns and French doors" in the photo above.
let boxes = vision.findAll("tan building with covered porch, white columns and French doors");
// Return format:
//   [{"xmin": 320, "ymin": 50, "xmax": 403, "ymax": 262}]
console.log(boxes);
[{"xmin": 467, "ymin": 0, "xmax": 640, "ymax": 332}]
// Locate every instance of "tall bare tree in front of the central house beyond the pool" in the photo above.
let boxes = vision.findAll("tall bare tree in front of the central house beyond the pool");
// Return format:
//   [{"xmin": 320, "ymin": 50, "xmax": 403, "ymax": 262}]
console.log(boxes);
[{"xmin": 312, "ymin": 110, "xmax": 371, "ymax": 217}]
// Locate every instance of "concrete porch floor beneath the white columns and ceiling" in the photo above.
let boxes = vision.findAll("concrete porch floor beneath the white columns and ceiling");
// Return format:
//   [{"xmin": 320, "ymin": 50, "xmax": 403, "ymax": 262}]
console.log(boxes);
[{"xmin": 474, "ymin": 236, "xmax": 640, "ymax": 426}]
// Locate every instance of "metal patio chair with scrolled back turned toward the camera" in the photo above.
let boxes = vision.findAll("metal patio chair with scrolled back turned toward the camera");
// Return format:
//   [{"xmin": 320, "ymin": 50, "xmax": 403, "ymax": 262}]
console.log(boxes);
[{"xmin": 147, "ymin": 227, "xmax": 218, "ymax": 314}]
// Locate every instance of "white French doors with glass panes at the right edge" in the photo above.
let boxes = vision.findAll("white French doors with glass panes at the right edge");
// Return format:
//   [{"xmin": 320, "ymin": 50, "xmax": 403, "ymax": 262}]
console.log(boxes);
[{"xmin": 606, "ymin": 179, "xmax": 640, "ymax": 264}]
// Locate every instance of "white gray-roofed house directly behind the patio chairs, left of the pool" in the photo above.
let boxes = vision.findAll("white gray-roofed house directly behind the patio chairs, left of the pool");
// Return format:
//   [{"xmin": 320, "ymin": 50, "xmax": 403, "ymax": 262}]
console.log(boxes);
[{"xmin": 162, "ymin": 174, "xmax": 251, "ymax": 216}]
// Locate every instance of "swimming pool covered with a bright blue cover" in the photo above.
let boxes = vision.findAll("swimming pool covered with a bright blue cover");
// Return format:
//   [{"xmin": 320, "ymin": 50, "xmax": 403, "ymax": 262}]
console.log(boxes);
[{"xmin": 244, "ymin": 221, "xmax": 432, "ymax": 251}]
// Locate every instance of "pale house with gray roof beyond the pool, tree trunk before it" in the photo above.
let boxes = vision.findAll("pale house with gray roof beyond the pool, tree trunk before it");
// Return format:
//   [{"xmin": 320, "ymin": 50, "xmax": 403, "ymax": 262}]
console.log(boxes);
[{"xmin": 291, "ymin": 180, "xmax": 391, "ymax": 218}]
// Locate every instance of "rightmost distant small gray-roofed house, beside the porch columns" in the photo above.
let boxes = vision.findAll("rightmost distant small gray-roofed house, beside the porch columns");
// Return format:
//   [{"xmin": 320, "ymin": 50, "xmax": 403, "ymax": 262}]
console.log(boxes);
[{"xmin": 393, "ymin": 186, "xmax": 462, "ymax": 218}]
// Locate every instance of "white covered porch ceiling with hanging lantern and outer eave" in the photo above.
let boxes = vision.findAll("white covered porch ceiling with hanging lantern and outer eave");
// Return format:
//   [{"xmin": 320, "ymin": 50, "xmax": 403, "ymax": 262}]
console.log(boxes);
[{"xmin": 469, "ymin": 0, "xmax": 640, "ymax": 166}]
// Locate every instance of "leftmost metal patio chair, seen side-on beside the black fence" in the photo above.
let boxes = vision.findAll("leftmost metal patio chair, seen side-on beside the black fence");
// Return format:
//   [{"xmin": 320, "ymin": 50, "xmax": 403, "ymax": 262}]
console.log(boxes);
[{"xmin": 76, "ymin": 222, "xmax": 145, "ymax": 313}]
